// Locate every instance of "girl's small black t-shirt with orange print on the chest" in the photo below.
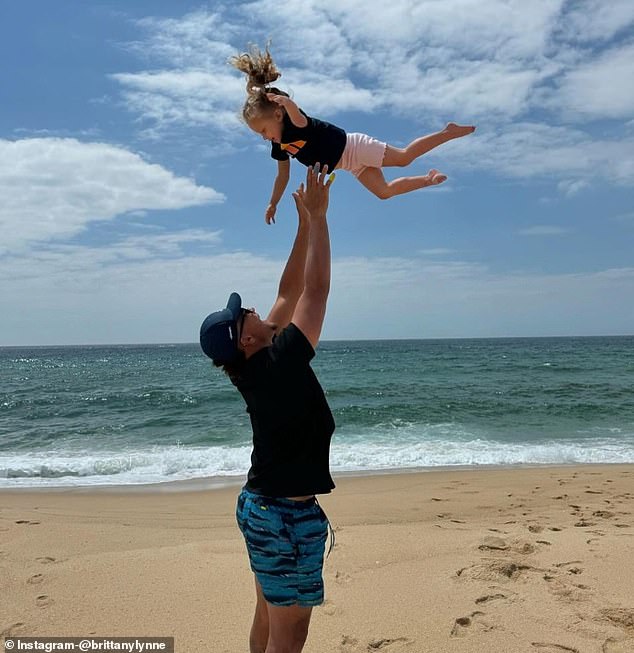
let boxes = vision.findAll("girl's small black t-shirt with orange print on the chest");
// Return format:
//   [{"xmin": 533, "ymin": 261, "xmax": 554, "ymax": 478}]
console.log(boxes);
[{"xmin": 271, "ymin": 109, "xmax": 346, "ymax": 172}]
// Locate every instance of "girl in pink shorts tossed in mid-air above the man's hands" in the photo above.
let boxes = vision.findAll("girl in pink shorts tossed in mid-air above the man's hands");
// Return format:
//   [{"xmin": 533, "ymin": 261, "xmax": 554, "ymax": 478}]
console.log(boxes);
[{"xmin": 230, "ymin": 47, "xmax": 475, "ymax": 224}]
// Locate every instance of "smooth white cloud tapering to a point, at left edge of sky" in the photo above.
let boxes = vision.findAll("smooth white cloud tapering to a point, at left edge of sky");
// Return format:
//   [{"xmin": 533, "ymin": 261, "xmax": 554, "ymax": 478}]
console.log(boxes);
[{"xmin": 0, "ymin": 138, "xmax": 224, "ymax": 250}]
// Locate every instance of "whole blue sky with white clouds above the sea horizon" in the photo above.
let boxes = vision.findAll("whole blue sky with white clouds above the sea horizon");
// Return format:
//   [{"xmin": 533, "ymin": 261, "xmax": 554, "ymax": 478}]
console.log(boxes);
[{"xmin": 0, "ymin": 0, "xmax": 634, "ymax": 345}]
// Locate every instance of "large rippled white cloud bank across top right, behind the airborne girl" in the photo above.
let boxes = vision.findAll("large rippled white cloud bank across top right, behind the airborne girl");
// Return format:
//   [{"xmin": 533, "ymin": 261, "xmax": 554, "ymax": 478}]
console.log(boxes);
[{"xmin": 106, "ymin": 0, "xmax": 634, "ymax": 187}]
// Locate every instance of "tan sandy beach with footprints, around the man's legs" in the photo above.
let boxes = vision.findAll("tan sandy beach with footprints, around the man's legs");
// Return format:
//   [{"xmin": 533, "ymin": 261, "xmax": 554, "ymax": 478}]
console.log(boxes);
[{"xmin": 0, "ymin": 465, "xmax": 634, "ymax": 653}]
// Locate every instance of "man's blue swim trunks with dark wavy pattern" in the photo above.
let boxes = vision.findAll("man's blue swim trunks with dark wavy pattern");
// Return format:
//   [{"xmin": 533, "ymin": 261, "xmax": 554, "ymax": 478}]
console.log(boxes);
[{"xmin": 236, "ymin": 489, "xmax": 329, "ymax": 607}]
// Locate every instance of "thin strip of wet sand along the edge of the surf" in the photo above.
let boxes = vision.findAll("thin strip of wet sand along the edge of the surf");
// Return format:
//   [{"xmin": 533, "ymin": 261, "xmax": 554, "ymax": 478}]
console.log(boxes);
[{"xmin": 0, "ymin": 462, "xmax": 634, "ymax": 495}]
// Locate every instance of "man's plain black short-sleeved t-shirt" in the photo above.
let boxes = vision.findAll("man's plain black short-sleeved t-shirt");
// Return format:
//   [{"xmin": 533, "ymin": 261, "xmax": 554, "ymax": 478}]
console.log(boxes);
[{"xmin": 236, "ymin": 323, "xmax": 335, "ymax": 497}]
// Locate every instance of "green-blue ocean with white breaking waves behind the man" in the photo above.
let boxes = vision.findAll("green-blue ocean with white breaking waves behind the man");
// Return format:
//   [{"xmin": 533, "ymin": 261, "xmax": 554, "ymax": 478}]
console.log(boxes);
[{"xmin": 0, "ymin": 336, "xmax": 634, "ymax": 488}]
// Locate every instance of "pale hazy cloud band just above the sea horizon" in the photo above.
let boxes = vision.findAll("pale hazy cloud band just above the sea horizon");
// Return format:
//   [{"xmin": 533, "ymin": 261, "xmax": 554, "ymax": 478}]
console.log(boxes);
[{"xmin": 0, "ymin": 246, "xmax": 634, "ymax": 345}]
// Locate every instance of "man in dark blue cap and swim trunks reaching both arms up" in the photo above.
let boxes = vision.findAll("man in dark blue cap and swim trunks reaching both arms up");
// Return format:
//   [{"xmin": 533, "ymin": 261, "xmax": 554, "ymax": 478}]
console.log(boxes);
[{"xmin": 200, "ymin": 164, "xmax": 334, "ymax": 653}]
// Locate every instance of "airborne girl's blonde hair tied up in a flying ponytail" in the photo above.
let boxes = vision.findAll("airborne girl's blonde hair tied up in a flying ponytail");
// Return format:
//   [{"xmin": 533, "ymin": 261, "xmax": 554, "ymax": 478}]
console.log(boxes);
[{"xmin": 229, "ymin": 45, "xmax": 288, "ymax": 123}]
